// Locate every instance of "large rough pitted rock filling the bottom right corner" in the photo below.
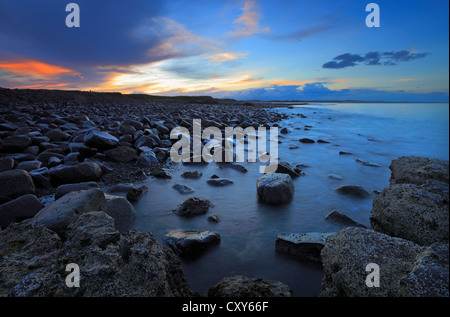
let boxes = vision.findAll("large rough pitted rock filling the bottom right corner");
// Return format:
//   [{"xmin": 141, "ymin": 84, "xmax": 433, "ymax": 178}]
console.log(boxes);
[{"xmin": 321, "ymin": 227, "xmax": 449, "ymax": 297}]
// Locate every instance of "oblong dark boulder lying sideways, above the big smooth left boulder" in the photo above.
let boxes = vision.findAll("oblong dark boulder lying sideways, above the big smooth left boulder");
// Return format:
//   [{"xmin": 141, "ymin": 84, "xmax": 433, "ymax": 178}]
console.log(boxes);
[{"xmin": 50, "ymin": 162, "xmax": 102, "ymax": 184}]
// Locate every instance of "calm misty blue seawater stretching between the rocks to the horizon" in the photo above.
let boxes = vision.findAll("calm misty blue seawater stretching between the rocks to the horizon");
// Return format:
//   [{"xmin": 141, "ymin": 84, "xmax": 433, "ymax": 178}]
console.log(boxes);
[{"xmin": 129, "ymin": 103, "xmax": 449, "ymax": 296}]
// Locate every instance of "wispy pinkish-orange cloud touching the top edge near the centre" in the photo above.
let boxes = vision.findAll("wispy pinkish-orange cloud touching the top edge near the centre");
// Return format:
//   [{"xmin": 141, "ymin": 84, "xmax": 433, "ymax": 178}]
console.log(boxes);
[{"xmin": 232, "ymin": 0, "xmax": 270, "ymax": 36}]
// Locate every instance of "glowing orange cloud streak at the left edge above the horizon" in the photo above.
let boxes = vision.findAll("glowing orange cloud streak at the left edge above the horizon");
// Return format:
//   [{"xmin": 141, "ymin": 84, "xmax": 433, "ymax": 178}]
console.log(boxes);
[{"xmin": 0, "ymin": 59, "xmax": 80, "ymax": 79}]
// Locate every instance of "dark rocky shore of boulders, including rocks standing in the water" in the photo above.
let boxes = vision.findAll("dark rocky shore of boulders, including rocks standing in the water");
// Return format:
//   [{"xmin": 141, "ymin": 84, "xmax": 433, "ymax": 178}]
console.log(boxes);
[{"xmin": 0, "ymin": 89, "xmax": 449, "ymax": 297}]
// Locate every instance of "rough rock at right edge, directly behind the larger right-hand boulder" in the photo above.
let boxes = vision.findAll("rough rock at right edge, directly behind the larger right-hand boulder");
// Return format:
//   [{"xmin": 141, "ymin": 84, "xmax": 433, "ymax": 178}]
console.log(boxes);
[{"xmin": 389, "ymin": 156, "xmax": 449, "ymax": 185}]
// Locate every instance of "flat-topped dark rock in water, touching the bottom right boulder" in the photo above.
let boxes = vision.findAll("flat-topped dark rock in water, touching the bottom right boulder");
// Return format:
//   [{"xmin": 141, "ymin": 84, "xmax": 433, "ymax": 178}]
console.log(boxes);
[{"xmin": 275, "ymin": 232, "xmax": 332, "ymax": 263}]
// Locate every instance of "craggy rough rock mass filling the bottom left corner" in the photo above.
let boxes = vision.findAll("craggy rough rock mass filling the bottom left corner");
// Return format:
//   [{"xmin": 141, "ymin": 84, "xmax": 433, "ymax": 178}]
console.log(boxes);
[{"xmin": 0, "ymin": 212, "xmax": 194, "ymax": 297}]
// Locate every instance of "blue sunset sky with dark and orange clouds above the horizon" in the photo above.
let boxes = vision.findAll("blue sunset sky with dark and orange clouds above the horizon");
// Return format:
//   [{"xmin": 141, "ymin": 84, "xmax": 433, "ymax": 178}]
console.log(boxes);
[{"xmin": 0, "ymin": 0, "xmax": 449, "ymax": 102}]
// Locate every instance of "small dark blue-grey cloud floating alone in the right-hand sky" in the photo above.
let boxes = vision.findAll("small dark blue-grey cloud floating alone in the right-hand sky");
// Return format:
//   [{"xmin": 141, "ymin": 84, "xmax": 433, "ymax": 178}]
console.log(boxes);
[{"xmin": 322, "ymin": 50, "xmax": 429, "ymax": 69}]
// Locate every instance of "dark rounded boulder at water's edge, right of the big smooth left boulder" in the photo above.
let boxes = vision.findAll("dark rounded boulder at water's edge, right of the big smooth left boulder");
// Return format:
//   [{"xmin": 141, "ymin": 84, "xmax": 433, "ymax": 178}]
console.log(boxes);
[{"xmin": 105, "ymin": 195, "xmax": 136, "ymax": 231}]
